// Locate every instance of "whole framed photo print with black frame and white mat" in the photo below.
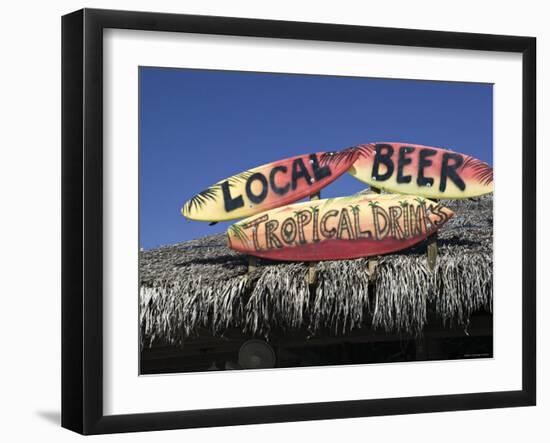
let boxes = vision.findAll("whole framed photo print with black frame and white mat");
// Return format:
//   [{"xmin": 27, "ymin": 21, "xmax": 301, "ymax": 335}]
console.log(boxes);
[{"xmin": 62, "ymin": 9, "xmax": 536, "ymax": 434}]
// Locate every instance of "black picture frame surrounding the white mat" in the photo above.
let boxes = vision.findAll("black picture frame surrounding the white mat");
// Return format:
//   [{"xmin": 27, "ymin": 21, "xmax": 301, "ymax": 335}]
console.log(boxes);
[{"xmin": 62, "ymin": 9, "xmax": 536, "ymax": 434}]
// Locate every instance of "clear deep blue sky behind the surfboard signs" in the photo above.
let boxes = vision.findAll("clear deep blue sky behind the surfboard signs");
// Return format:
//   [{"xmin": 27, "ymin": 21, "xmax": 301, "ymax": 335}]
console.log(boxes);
[{"xmin": 139, "ymin": 67, "xmax": 493, "ymax": 249}]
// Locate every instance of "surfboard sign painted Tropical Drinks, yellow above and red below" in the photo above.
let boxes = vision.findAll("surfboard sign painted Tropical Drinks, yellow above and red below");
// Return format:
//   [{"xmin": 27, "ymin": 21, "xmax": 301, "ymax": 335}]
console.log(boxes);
[{"xmin": 227, "ymin": 194, "xmax": 453, "ymax": 261}]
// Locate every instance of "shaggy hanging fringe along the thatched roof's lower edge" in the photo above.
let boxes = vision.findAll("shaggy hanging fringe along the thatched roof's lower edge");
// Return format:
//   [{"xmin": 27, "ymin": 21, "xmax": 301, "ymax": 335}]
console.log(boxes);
[{"xmin": 140, "ymin": 254, "xmax": 493, "ymax": 346}]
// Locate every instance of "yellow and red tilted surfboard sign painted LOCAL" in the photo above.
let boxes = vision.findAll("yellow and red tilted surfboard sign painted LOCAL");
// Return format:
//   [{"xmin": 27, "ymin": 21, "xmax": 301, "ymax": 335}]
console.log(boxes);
[{"xmin": 181, "ymin": 148, "xmax": 359, "ymax": 222}]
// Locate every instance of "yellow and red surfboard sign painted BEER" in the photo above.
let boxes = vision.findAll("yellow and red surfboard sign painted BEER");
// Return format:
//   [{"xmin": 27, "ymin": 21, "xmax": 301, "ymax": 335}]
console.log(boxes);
[{"xmin": 349, "ymin": 143, "xmax": 493, "ymax": 199}]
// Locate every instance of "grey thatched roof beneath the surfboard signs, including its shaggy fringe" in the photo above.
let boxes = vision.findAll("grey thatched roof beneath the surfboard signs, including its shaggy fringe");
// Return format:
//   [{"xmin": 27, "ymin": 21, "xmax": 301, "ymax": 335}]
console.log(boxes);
[{"xmin": 139, "ymin": 196, "xmax": 493, "ymax": 346}]
